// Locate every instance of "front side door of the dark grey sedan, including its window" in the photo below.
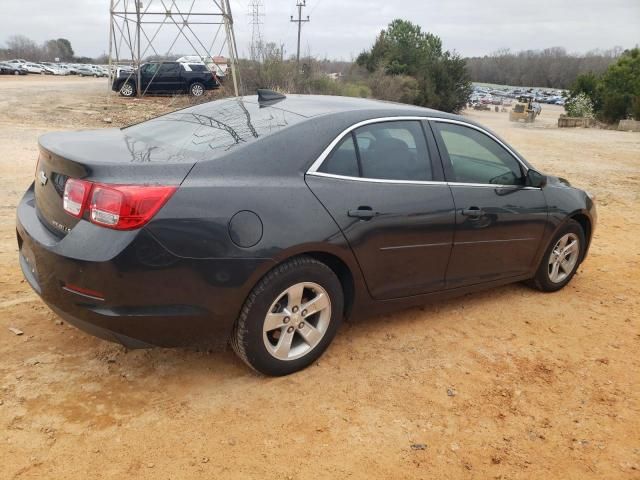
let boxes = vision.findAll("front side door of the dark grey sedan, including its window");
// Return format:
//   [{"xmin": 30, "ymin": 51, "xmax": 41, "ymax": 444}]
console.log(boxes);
[{"xmin": 430, "ymin": 120, "xmax": 547, "ymax": 288}]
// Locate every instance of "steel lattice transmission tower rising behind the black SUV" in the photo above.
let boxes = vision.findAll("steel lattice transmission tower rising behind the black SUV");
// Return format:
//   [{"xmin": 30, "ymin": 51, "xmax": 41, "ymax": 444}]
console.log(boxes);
[{"xmin": 109, "ymin": 0, "xmax": 242, "ymax": 96}]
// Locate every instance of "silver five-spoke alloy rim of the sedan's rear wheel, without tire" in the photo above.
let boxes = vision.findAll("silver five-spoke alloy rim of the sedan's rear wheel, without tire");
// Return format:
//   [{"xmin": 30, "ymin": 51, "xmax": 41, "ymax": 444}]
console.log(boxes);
[{"xmin": 262, "ymin": 282, "xmax": 331, "ymax": 360}]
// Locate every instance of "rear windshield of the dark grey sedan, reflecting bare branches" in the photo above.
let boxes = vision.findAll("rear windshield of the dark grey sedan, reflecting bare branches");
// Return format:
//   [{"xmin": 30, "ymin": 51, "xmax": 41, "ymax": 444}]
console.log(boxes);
[{"xmin": 124, "ymin": 98, "xmax": 304, "ymax": 153}]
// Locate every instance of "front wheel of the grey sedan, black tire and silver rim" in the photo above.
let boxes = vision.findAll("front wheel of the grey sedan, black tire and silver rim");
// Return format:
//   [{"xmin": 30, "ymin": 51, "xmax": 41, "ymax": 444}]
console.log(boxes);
[{"xmin": 528, "ymin": 220, "xmax": 587, "ymax": 292}]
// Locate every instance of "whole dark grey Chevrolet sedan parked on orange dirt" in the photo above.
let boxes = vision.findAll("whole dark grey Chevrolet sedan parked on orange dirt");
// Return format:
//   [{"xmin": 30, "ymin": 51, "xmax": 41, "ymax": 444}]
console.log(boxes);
[{"xmin": 17, "ymin": 91, "xmax": 596, "ymax": 375}]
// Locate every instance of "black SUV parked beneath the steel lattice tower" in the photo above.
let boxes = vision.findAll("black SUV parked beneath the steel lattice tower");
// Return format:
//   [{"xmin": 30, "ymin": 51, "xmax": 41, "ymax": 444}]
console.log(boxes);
[{"xmin": 111, "ymin": 62, "xmax": 220, "ymax": 97}]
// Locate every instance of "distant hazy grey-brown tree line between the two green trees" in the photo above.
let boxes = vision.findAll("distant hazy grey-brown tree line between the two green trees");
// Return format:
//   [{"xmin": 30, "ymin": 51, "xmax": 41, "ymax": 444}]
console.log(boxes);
[{"xmin": 466, "ymin": 47, "xmax": 623, "ymax": 89}]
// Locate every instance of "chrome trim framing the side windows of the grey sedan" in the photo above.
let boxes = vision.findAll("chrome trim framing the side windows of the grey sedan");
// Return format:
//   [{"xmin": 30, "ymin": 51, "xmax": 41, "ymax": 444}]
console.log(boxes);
[{"xmin": 306, "ymin": 116, "xmax": 540, "ymax": 190}]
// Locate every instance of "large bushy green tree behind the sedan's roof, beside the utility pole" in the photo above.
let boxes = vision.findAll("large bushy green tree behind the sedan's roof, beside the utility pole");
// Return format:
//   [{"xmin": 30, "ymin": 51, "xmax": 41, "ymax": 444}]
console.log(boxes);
[{"xmin": 356, "ymin": 19, "xmax": 471, "ymax": 112}]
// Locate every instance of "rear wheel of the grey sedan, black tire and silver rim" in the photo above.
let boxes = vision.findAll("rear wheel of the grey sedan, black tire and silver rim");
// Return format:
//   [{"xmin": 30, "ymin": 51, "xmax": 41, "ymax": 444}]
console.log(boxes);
[{"xmin": 231, "ymin": 256, "xmax": 344, "ymax": 376}]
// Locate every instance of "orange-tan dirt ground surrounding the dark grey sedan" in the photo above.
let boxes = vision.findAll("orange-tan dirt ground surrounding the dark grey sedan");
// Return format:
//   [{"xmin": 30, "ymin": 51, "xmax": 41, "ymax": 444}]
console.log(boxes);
[{"xmin": 0, "ymin": 76, "xmax": 640, "ymax": 479}]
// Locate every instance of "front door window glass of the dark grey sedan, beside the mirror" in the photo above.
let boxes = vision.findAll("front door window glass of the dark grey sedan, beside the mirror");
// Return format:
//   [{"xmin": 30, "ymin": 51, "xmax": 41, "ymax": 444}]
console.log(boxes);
[{"xmin": 434, "ymin": 122, "xmax": 524, "ymax": 185}]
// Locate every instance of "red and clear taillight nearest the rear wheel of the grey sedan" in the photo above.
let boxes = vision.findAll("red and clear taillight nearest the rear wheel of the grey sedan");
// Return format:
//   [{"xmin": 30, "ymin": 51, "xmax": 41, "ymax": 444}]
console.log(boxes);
[{"xmin": 64, "ymin": 178, "xmax": 177, "ymax": 230}]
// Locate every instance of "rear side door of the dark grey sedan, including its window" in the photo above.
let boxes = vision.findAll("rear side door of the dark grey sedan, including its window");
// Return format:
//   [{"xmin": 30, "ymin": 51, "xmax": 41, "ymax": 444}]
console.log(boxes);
[{"xmin": 306, "ymin": 119, "xmax": 455, "ymax": 300}]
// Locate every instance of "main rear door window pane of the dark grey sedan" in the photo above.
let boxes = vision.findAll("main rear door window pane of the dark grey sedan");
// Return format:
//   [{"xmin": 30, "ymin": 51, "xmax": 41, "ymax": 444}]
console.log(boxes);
[{"xmin": 355, "ymin": 121, "xmax": 433, "ymax": 181}]
